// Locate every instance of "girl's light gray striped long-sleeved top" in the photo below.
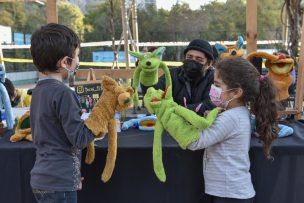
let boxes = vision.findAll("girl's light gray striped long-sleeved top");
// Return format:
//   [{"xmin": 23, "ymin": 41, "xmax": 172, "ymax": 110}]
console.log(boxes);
[{"xmin": 188, "ymin": 107, "xmax": 255, "ymax": 199}]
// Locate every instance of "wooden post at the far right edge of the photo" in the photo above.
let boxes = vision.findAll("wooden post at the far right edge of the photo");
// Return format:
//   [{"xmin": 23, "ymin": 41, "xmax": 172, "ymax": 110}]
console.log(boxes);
[{"xmin": 295, "ymin": 16, "xmax": 304, "ymax": 120}]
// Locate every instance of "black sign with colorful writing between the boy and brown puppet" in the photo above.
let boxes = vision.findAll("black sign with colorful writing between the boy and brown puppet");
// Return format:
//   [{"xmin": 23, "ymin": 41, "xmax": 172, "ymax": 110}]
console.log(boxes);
[{"xmin": 74, "ymin": 81, "xmax": 102, "ymax": 113}]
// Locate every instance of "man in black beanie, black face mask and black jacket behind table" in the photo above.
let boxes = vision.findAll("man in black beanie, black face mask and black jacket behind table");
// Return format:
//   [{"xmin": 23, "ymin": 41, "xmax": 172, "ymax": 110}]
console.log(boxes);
[{"xmin": 141, "ymin": 39, "xmax": 215, "ymax": 115}]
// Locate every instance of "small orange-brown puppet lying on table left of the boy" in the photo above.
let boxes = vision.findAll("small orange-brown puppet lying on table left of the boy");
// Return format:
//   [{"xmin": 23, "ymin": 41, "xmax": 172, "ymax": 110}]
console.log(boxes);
[{"xmin": 10, "ymin": 111, "xmax": 33, "ymax": 142}]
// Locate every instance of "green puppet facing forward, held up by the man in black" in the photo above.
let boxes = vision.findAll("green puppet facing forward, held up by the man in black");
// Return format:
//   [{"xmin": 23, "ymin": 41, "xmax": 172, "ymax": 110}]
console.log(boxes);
[{"xmin": 129, "ymin": 47, "xmax": 172, "ymax": 107}]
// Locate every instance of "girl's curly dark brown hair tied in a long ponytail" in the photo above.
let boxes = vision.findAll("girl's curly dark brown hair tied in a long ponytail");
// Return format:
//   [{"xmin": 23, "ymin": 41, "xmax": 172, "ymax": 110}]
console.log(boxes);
[{"xmin": 216, "ymin": 57, "xmax": 278, "ymax": 159}]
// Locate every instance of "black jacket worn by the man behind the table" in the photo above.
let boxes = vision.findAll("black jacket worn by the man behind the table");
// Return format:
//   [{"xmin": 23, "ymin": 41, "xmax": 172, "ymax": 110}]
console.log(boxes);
[{"xmin": 141, "ymin": 67, "xmax": 215, "ymax": 115}]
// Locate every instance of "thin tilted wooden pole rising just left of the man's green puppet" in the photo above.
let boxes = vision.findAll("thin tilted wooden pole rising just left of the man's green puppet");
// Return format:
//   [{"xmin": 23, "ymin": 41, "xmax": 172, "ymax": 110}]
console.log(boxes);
[{"xmin": 120, "ymin": 0, "xmax": 130, "ymax": 69}]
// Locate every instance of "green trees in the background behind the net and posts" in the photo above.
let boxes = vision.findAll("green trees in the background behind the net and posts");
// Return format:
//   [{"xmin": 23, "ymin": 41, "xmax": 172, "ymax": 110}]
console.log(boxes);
[{"xmin": 0, "ymin": 0, "xmax": 283, "ymax": 70}]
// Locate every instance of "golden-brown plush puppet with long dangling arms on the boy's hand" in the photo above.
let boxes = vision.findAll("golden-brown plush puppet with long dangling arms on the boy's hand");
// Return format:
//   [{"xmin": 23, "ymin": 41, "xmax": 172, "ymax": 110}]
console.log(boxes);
[{"xmin": 84, "ymin": 76, "xmax": 134, "ymax": 182}]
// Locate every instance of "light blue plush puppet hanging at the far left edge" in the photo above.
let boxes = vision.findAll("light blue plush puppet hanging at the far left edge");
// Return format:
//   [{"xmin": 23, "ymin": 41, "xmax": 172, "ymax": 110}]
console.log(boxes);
[{"xmin": 0, "ymin": 63, "xmax": 15, "ymax": 132}]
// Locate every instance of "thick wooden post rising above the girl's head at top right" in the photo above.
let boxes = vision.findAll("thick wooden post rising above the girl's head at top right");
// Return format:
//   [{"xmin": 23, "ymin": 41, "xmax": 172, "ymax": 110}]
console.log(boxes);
[{"xmin": 246, "ymin": 0, "xmax": 257, "ymax": 54}]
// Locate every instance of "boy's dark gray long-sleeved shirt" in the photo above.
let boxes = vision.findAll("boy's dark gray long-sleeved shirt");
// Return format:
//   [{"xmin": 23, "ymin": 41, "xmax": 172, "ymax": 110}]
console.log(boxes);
[{"xmin": 30, "ymin": 79, "xmax": 94, "ymax": 191}]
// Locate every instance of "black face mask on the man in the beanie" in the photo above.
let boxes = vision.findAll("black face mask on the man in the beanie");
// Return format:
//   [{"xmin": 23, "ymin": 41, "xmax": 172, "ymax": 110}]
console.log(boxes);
[{"xmin": 183, "ymin": 59, "xmax": 204, "ymax": 80}]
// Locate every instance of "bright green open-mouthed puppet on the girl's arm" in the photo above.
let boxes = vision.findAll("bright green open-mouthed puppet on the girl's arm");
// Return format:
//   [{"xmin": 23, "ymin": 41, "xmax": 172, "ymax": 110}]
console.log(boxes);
[{"xmin": 144, "ymin": 86, "xmax": 218, "ymax": 182}]
